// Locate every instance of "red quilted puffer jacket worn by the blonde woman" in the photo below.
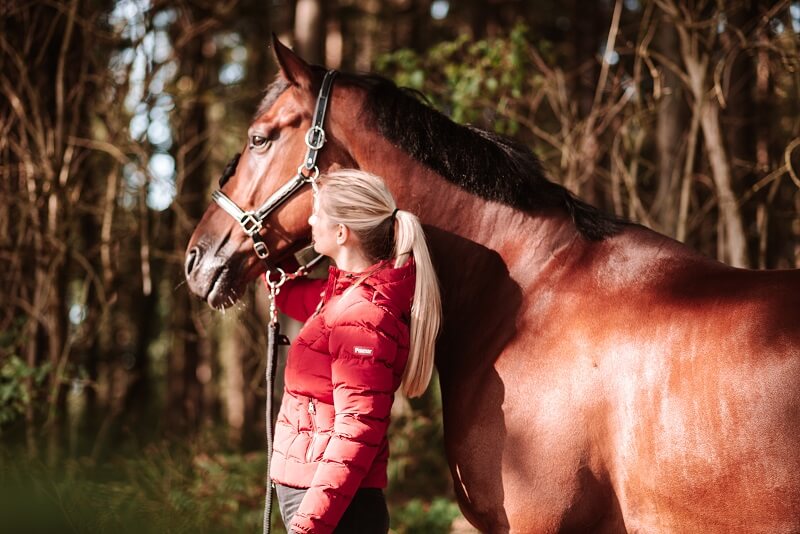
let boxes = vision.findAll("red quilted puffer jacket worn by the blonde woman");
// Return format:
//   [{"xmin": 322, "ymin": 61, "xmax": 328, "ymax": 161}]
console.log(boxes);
[{"xmin": 270, "ymin": 260, "xmax": 416, "ymax": 533}]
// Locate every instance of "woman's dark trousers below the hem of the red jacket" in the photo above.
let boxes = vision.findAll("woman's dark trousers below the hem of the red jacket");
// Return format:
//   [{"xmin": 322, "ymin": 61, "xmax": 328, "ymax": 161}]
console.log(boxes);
[{"xmin": 275, "ymin": 484, "xmax": 389, "ymax": 534}]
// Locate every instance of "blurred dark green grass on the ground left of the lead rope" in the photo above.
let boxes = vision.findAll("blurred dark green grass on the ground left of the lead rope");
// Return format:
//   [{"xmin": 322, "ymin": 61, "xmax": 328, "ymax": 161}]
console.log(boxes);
[{"xmin": 0, "ymin": 444, "xmax": 282, "ymax": 533}]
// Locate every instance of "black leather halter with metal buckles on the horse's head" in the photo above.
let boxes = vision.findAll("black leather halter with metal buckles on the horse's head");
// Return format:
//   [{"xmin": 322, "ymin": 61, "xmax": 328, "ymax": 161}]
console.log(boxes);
[{"xmin": 211, "ymin": 70, "xmax": 337, "ymax": 260}]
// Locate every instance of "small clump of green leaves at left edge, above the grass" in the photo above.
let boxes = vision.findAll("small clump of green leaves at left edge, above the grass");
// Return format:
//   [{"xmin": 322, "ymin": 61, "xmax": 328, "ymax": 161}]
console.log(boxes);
[{"xmin": 0, "ymin": 355, "xmax": 50, "ymax": 429}]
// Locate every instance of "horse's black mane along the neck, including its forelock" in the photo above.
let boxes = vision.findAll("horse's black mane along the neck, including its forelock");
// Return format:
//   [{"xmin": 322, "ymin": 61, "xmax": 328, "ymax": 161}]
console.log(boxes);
[{"xmin": 259, "ymin": 66, "xmax": 624, "ymax": 241}]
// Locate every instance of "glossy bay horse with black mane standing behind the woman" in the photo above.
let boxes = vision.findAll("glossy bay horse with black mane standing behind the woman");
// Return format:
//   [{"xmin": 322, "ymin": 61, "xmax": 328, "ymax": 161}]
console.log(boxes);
[{"xmin": 186, "ymin": 40, "xmax": 800, "ymax": 533}]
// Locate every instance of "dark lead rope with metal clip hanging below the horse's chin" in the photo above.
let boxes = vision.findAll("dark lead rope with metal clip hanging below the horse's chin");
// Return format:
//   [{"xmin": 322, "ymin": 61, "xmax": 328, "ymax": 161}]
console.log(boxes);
[{"xmin": 263, "ymin": 255, "xmax": 323, "ymax": 534}]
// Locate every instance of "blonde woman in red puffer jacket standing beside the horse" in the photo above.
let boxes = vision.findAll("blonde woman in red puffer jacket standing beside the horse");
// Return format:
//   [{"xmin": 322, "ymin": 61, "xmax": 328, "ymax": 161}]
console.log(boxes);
[{"xmin": 270, "ymin": 170, "xmax": 441, "ymax": 534}]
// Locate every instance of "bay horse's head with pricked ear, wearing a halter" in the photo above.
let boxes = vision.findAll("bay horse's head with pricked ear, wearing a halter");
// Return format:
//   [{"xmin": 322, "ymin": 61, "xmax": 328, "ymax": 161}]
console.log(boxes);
[{"xmin": 185, "ymin": 39, "xmax": 354, "ymax": 308}]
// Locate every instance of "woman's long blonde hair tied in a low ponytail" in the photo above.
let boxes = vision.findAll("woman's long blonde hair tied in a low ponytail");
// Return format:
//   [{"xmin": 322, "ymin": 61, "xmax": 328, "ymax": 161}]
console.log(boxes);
[{"xmin": 319, "ymin": 169, "xmax": 442, "ymax": 397}]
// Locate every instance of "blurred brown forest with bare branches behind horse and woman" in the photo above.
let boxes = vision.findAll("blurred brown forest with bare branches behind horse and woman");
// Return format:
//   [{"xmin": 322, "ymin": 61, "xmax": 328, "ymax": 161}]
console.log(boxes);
[{"xmin": 0, "ymin": 0, "xmax": 800, "ymax": 532}]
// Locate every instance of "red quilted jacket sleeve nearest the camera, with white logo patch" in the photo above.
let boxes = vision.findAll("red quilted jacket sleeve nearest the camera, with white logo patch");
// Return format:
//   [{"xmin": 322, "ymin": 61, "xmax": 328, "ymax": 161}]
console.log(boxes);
[{"xmin": 291, "ymin": 303, "xmax": 397, "ymax": 534}]
